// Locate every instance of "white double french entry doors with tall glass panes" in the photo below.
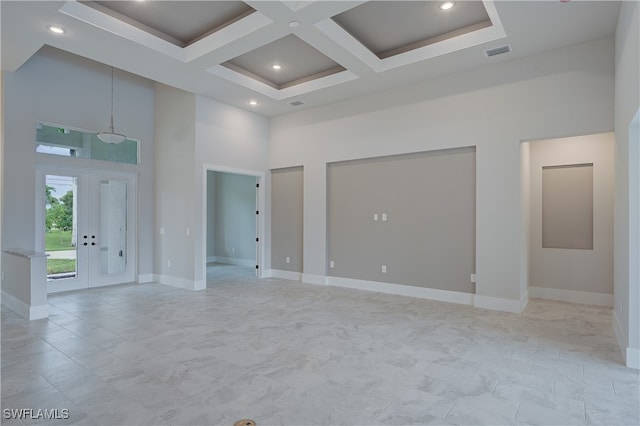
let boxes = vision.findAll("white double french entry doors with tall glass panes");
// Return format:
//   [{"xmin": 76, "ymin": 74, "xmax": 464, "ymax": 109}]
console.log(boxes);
[{"xmin": 36, "ymin": 167, "xmax": 136, "ymax": 293}]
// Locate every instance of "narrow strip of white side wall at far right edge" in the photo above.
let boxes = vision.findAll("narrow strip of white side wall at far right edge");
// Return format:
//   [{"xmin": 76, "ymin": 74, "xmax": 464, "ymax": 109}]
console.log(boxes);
[{"xmin": 614, "ymin": 1, "xmax": 640, "ymax": 368}]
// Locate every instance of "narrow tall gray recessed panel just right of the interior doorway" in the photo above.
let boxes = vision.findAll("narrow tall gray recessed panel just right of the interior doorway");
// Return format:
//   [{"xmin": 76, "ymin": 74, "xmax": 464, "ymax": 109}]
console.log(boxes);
[{"xmin": 271, "ymin": 167, "xmax": 304, "ymax": 272}]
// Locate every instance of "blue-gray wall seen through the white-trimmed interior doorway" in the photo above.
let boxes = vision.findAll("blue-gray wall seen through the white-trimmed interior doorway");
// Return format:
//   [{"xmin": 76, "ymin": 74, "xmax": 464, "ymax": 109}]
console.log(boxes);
[{"xmin": 212, "ymin": 171, "xmax": 257, "ymax": 262}]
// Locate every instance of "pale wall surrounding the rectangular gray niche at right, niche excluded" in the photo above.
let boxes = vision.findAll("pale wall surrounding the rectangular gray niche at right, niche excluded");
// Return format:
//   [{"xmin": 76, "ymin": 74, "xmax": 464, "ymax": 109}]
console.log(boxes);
[{"xmin": 530, "ymin": 133, "xmax": 614, "ymax": 294}]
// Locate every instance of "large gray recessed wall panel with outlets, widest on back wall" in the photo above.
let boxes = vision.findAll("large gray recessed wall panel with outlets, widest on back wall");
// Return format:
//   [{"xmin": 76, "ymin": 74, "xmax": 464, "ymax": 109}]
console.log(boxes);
[{"xmin": 327, "ymin": 148, "xmax": 475, "ymax": 293}]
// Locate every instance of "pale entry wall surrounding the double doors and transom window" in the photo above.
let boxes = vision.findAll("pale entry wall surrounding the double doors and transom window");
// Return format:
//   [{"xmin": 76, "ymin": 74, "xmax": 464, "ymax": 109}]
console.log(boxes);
[{"xmin": 2, "ymin": 47, "xmax": 154, "ymax": 302}]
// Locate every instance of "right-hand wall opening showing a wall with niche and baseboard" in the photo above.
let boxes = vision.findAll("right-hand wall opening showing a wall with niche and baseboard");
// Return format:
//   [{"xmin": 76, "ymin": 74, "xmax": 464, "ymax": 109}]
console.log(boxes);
[{"xmin": 521, "ymin": 133, "xmax": 615, "ymax": 307}]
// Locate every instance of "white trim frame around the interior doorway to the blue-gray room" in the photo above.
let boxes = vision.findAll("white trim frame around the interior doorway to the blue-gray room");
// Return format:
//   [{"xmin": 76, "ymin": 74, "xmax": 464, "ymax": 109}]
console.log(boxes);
[{"xmin": 202, "ymin": 164, "xmax": 267, "ymax": 290}]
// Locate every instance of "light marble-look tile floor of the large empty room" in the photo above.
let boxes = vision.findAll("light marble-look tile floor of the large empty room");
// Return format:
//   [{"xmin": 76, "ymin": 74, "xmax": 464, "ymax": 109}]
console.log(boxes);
[{"xmin": 1, "ymin": 278, "xmax": 640, "ymax": 426}]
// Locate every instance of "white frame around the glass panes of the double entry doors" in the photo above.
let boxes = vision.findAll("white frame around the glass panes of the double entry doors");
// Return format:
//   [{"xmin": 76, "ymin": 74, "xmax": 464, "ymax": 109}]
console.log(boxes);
[{"xmin": 35, "ymin": 164, "xmax": 138, "ymax": 293}]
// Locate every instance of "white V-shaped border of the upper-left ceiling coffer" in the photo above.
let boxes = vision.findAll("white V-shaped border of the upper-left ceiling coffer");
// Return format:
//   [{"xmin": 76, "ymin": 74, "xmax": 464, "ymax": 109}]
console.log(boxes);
[{"xmin": 59, "ymin": 1, "xmax": 273, "ymax": 63}]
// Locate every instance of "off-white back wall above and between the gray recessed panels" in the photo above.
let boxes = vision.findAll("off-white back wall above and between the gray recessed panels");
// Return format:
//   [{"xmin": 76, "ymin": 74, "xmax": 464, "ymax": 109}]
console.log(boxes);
[{"xmin": 269, "ymin": 38, "xmax": 614, "ymax": 310}]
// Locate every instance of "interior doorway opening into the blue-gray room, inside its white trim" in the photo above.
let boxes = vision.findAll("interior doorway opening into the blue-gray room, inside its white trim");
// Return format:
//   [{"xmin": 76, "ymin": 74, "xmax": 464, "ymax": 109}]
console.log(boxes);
[{"xmin": 205, "ymin": 170, "xmax": 260, "ymax": 287}]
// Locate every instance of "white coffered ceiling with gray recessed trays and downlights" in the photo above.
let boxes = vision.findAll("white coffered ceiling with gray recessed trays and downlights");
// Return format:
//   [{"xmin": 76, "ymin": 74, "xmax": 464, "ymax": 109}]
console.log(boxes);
[{"xmin": 0, "ymin": 0, "xmax": 620, "ymax": 116}]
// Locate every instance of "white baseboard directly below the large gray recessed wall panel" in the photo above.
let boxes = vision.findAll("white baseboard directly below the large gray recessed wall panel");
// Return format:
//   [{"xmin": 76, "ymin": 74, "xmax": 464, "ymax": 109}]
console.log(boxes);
[{"xmin": 327, "ymin": 277, "xmax": 473, "ymax": 305}]
